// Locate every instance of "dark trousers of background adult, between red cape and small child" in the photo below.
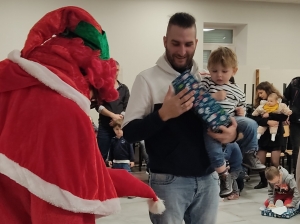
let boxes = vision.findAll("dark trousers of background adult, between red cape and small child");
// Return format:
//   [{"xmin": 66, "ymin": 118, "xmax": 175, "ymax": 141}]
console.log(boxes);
[{"xmin": 97, "ymin": 125, "xmax": 116, "ymax": 161}]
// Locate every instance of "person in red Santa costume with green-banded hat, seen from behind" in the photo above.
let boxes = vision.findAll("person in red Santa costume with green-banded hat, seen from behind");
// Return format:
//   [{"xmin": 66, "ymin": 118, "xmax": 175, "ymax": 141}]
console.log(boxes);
[{"xmin": 0, "ymin": 7, "xmax": 164, "ymax": 224}]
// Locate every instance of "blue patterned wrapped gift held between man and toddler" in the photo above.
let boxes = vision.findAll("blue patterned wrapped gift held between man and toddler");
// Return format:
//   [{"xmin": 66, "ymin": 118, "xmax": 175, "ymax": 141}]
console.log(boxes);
[{"xmin": 172, "ymin": 72, "xmax": 231, "ymax": 132}]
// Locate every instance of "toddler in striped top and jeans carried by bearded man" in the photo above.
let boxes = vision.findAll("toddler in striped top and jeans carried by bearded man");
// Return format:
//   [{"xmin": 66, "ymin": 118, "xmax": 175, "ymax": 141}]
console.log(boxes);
[{"xmin": 200, "ymin": 47, "xmax": 265, "ymax": 197}]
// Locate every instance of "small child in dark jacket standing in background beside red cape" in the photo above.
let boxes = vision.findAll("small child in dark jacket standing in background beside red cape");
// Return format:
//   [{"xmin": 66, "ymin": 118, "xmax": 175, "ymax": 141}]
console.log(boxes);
[{"xmin": 108, "ymin": 120, "xmax": 134, "ymax": 172}]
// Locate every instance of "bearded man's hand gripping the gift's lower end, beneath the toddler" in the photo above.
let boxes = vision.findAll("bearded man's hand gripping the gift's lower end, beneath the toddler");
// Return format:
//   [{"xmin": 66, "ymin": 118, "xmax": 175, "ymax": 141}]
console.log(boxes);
[{"xmin": 208, "ymin": 117, "xmax": 237, "ymax": 144}]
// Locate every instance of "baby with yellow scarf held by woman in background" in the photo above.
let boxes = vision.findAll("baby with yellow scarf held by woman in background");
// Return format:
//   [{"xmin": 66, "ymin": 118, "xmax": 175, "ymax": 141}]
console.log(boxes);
[{"xmin": 252, "ymin": 93, "xmax": 292, "ymax": 141}]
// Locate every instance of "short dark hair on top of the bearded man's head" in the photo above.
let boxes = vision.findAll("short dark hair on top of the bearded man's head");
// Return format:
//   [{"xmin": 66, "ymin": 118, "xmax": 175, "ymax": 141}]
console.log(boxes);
[{"xmin": 168, "ymin": 12, "xmax": 196, "ymax": 32}]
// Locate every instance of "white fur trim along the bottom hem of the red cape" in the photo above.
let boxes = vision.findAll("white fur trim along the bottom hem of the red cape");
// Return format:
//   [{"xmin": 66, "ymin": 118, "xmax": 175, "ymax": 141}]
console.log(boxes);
[{"xmin": 0, "ymin": 153, "xmax": 121, "ymax": 216}]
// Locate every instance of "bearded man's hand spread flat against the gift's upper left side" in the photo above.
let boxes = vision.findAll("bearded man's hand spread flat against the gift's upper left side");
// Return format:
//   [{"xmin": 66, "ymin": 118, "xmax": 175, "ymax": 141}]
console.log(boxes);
[{"xmin": 158, "ymin": 86, "xmax": 195, "ymax": 121}]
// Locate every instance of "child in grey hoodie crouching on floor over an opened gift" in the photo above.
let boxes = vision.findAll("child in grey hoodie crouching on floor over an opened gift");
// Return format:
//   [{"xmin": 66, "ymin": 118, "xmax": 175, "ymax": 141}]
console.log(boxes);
[{"xmin": 265, "ymin": 166, "xmax": 300, "ymax": 208}]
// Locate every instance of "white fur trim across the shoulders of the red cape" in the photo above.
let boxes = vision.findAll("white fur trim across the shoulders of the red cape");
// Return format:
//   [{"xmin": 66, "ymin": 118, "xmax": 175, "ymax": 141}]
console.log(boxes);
[{"xmin": 8, "ymin": 50, "xmax": 91, "ymax": 114}]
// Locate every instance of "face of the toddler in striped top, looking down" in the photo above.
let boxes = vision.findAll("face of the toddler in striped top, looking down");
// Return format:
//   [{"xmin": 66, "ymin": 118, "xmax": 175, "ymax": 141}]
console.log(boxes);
[{"xmin": 209, "ymin": 63, "xmax": 237, "ymax": 85}]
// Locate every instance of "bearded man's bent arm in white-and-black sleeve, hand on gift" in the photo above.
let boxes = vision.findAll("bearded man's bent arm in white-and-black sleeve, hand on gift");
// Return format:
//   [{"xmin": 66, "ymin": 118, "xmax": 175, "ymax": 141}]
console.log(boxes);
[{"xmin": 123, "ymin": 75, "xmax": 195, "ymax": 143}]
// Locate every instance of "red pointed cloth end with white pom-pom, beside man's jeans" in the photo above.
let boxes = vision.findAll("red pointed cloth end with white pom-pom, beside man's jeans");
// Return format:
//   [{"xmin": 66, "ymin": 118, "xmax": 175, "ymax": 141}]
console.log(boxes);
[{"xmin": 108, "ymin": 169, "xmax": 166, "ymax": 214}]
